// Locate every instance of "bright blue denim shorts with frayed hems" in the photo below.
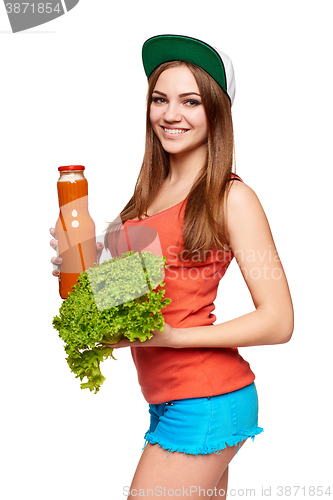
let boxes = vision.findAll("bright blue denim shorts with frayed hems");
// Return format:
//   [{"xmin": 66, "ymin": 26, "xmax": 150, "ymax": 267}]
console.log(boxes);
[{"xmin": 145, "ymin": 382, "xmax": 263, "ymax": 456}]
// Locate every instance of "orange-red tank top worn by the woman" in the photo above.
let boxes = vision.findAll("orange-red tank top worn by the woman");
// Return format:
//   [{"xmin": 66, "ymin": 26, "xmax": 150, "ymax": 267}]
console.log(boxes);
[{"xmin": 115, "ymin": 179, "xmax": 255, "ymax": 404}]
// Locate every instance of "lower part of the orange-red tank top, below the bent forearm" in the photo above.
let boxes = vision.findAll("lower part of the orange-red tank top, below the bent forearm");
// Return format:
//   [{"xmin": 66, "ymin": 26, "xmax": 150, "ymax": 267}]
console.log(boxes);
[{"xmin": 131, "ymin": 347, "xmax": 255, "ymax": 404}]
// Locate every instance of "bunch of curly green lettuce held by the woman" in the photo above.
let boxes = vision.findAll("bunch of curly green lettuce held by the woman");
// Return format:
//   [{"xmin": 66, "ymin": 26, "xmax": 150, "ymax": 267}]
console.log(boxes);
[{"xmin": 53, "ymin": 252, "xmax": 171, "ymax": 394}]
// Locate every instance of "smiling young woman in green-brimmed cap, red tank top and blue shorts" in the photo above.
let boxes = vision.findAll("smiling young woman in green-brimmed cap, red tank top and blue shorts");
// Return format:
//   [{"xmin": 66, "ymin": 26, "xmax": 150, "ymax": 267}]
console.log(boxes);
[{"xmin": 51, "ymin": 35, "xmax": 293, "ymax": 499}]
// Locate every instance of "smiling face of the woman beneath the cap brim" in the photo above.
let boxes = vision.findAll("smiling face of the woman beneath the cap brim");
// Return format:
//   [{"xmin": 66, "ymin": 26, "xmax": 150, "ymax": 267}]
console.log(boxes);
[{"xmin": 150, "ymin": 65, "xmax": 208, "ymax": 154}]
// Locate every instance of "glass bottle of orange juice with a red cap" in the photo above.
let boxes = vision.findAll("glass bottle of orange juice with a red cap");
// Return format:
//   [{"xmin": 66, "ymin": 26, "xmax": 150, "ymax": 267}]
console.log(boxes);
[{"xmin": 55, "ymin": 165, "xmax": 97, "ymax": 299}]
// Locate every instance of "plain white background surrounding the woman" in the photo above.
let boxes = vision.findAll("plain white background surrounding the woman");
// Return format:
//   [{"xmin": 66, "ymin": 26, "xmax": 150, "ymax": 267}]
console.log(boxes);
[{"xmin": 0, "ymin": 0, "xmax": 333, "ymax": 500}]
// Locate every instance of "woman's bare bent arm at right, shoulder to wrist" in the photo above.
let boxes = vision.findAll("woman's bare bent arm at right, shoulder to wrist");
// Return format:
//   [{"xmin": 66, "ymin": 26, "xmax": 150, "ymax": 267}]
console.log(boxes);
[{"xmin": 174, "ymin": 182, "xmax": 294, "ymax": 347}]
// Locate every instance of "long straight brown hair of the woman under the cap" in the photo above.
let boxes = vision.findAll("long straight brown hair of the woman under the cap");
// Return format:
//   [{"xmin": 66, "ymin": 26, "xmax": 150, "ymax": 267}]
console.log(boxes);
[{"xmin": 105, "ymin": 61, "xmax": 234, "ymax": 257}]
